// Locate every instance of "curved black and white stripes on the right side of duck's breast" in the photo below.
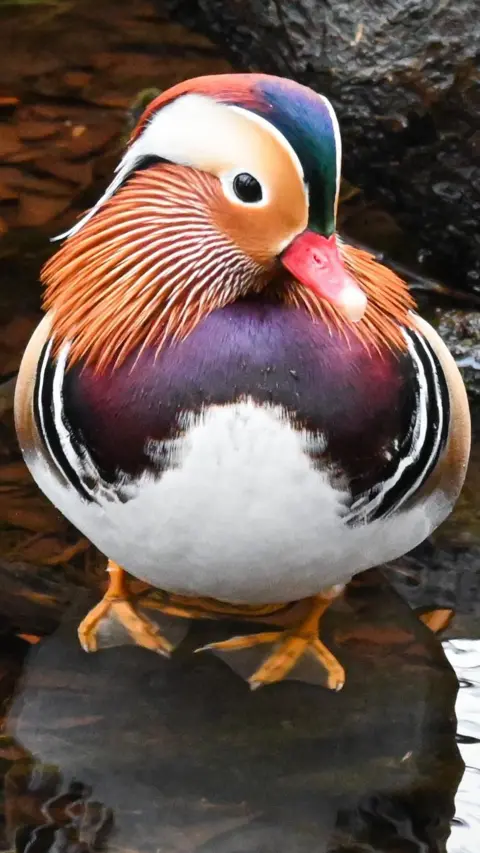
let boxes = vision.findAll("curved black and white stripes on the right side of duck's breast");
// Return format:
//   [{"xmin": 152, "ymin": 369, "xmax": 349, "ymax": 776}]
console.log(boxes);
[{"xmin": 346, "ymin": 329, "xmax": 450, "ymax": 525}]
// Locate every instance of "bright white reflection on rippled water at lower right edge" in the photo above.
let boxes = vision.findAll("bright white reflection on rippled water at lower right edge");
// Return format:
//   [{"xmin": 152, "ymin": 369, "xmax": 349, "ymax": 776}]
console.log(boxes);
[{"xmin": 443, "ymin": 639, "xmax": 480, "ymax": 853}]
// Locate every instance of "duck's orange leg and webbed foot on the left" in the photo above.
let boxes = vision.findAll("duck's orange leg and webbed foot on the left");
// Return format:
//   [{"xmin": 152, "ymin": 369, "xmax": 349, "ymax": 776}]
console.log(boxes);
[{"xmin": 78, "ymin": 560, "xmax": 173, "ymax": 657}]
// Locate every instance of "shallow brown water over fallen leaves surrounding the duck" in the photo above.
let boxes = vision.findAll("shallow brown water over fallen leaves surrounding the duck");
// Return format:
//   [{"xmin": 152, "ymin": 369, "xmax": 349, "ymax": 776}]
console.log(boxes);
[{"xmin": 0, "ymin": 0, "xmax": 480, "ymax": 853}]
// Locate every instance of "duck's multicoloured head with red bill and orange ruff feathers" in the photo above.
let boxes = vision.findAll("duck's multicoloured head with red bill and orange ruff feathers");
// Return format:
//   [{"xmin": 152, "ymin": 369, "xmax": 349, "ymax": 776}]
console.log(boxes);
[{"xmin": 43, "ymin": 74, "xmax": 411, "ymax": 366}]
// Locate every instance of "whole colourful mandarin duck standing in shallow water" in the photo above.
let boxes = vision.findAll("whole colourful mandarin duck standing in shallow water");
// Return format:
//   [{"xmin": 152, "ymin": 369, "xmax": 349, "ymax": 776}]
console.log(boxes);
[{"xmin": 16, "ymin": 74, "xmax": 470, "ymax": 689}]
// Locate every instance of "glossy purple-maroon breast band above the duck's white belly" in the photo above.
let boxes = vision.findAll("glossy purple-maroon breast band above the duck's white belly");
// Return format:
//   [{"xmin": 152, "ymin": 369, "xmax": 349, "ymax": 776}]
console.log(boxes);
[{"xmin": 64, "ymin": 302, "xmax": 415, "ymax": 492}]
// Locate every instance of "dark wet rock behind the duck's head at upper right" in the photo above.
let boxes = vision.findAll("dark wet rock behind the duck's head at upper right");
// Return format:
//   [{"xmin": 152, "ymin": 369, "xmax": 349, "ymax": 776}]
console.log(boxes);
[{"xmin": 162, "ymin": 0, "xmax": 480, "ymax": 288}]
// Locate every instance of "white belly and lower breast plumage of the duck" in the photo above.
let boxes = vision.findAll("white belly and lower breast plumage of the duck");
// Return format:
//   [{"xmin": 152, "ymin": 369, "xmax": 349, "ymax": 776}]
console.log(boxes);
[{"xmin": 29, "ymin": 400, "xmax": 448, "ymax": 603}]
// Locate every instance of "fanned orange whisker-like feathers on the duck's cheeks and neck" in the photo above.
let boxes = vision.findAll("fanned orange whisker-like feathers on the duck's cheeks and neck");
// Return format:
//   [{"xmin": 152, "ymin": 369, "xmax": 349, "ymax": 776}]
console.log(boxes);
[{"xmin": 42, "ymin": 164, "xmax": 414, "ymax": 370}]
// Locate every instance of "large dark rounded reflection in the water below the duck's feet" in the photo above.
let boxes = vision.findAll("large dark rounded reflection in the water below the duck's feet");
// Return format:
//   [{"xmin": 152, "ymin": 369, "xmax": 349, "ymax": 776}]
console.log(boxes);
[{"xmin": 0, "ymin": 576, "xmax": 463, "ymax": 853}]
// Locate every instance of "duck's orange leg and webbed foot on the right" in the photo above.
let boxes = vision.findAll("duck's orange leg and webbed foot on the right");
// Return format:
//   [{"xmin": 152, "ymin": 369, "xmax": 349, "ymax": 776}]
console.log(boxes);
[{"xmin": 197, "ymin": 586, "xmax": 345, "ymax": 690}]
